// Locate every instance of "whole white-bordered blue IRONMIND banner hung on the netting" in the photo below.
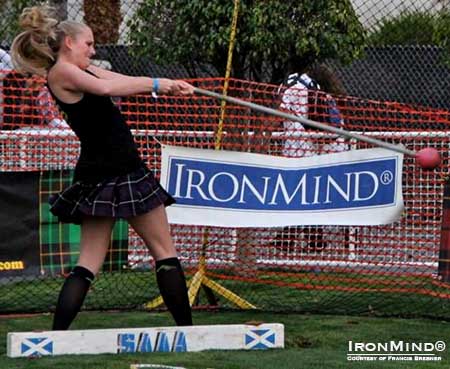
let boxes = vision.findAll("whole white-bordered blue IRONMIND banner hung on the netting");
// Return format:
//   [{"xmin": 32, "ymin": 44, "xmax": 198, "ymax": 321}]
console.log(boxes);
[{"xmin": 161, "ymin": 146, "xmax": 403, "ymax": 227}]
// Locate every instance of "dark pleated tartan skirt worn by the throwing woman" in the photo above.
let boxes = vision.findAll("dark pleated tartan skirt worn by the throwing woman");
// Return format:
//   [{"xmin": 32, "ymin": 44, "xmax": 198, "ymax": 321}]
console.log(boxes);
[{"xmin": 49, "ymin": 167, "xmax": 175, "ymax": 224}]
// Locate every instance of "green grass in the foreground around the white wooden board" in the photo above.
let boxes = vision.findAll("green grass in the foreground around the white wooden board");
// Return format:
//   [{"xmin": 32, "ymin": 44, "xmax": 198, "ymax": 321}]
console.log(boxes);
[{"xmin": 0, "ymin": 311, "xmax": 450, "ymax": 369}]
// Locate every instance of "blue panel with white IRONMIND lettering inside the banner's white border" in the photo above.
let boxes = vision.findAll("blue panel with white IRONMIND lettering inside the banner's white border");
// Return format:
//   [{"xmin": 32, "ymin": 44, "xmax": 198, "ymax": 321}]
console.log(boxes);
[{"xmin": 168, "ymin": 157, "xmax": 397, "ymax": 211}]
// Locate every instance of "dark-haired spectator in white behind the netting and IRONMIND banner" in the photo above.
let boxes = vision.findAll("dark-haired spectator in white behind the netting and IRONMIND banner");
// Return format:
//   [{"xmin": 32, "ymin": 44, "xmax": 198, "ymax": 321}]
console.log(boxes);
[{"xmin": 275, "ymin": 64, "xmax": 348, "ymax": 252}]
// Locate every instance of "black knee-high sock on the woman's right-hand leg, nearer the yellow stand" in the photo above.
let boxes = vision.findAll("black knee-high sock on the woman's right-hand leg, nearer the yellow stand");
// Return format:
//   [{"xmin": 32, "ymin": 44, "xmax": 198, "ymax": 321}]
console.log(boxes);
[{"xmin": 156, "ymin": 258, "xmax": 192, "ymax": 325}]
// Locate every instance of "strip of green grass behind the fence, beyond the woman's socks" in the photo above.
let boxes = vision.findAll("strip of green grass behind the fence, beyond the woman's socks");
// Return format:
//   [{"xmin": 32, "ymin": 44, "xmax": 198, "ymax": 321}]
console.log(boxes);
[{"xmin": 0, "ymin": 271, "xmax": 450, "ymax": 320}]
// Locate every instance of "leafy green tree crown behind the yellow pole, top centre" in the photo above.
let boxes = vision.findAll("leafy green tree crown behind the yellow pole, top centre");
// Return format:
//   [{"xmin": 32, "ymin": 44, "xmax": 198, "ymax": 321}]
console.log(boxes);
[{"xmin": 129, "ymin": 0, "xmax": 365, "ymax": 82}]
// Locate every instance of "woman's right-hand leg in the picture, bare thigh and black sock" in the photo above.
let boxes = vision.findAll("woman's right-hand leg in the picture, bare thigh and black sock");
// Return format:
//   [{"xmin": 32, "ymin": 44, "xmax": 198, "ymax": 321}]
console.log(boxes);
[{"xmin": 129, "ymin": 205, "xmax": 192, "ymax": 325}]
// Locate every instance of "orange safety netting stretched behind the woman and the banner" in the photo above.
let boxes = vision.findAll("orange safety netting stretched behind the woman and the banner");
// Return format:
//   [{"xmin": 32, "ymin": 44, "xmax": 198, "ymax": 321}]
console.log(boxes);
[{"xmin": 0, "ymin": 77, "xmax": 450, "ymax": 316}]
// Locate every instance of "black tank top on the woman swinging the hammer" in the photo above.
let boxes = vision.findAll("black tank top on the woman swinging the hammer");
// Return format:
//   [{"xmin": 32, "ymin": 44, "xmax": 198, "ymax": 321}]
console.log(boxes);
[{"xmin": 49, "ymin": 72, "xmax": 144, "ymax": 183}]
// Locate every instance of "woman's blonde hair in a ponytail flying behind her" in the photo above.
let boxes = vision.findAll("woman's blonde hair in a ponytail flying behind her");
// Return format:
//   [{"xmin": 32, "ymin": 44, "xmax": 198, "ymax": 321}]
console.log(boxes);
[{"xmin": 11, "ymin": 6, "xmax": 87, "ymax": 76}]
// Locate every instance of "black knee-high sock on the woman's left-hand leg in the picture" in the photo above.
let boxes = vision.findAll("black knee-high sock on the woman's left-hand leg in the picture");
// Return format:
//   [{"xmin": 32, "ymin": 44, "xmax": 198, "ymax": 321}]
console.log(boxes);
[{"xmin": 52, "ymin": 265, "xmax": 94, "ymax": 331}]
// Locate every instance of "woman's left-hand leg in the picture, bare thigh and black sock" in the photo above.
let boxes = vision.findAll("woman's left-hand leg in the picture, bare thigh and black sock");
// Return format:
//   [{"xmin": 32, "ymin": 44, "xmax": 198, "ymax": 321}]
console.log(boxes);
[{"xmin": 53, "ymin": 217, "xmax": 114, "ymax": 330}]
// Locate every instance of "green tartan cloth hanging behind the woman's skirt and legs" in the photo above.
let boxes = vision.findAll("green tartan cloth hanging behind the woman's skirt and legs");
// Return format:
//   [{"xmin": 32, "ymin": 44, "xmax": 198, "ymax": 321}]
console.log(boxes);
[{"xmin": 39, "ymin": 170, "xmax": 128, "ymax": 275}]
